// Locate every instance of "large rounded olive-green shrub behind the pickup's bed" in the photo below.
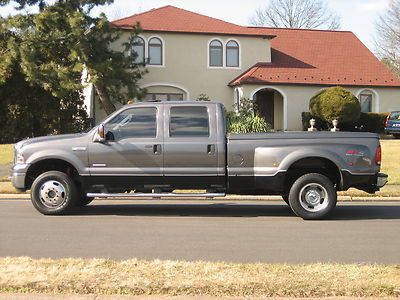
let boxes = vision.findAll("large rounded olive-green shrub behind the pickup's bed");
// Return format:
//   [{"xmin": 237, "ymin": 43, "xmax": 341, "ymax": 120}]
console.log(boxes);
[{"xmin": 310, "ymin": 86, "xmax": 361, "ymax": 124}]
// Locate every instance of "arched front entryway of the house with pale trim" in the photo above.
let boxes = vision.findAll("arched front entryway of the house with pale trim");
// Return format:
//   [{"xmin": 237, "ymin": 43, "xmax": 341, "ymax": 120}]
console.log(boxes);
[{"xmin": 250, "ymin": 86, "xmax": 287, "ymax": 130}]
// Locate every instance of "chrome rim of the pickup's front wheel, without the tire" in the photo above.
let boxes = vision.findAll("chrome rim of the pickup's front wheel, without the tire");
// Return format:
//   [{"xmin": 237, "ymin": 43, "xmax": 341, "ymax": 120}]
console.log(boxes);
[{"xmin": 39, "ymin": 180, "xmax": 68, "ymax": 208}]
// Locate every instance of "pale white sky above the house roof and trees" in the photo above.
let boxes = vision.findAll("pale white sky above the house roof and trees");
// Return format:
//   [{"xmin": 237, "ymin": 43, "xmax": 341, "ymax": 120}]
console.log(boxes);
[{"xmin": 0, "ymin": 0, "xmax": 390, "ymax": 51}]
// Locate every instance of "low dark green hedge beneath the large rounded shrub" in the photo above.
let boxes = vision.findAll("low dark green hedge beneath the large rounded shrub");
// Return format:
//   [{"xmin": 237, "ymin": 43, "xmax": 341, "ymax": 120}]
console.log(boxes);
[{"xmin": 301, "ymin": 112, "xmax": 388, "ymax": 134}]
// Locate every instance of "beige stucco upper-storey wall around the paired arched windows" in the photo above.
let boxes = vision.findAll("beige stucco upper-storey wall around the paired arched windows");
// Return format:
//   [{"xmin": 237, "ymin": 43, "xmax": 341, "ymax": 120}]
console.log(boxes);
[{"xmin": 115, "ymin": 32, "xmax": 271, "ymax": 102}]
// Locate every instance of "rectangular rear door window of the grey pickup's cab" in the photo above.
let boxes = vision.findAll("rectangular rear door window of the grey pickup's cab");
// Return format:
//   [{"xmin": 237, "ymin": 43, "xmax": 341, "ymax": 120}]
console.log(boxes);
[{"xmin": 169, "ymin": 106, "xmax": 210, "ymax": 137}]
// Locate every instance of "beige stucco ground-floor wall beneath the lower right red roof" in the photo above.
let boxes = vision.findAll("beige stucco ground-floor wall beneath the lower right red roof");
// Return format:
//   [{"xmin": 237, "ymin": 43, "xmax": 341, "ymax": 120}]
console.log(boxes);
[{"xmin": 242, "ymin": 85, "xmax": 400, "ymax": 130}]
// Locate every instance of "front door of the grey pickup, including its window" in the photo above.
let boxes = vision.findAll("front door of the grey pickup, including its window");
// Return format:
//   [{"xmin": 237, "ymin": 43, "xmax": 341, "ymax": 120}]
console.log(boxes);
[{"xmin": 89, "ymin": 105, "xmax": 163, "ymax": 190}]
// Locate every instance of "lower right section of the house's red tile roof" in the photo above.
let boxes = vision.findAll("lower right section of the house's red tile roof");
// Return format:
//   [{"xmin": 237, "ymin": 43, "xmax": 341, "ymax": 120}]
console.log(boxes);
[{"xmin": 229, "ymin": 28, "xmax": 400, "ymax": 86}]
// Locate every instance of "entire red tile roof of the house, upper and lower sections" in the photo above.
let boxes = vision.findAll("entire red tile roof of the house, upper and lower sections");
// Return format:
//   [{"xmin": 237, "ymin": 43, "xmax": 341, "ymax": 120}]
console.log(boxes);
[{"xmin": 112, "ymin": 5, "xmax": 400, "ymax": 87}]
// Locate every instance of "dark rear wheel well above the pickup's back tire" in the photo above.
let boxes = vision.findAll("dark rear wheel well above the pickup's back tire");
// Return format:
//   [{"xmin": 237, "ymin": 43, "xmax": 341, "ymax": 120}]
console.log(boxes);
[{"xmin": 284, "ymin": 157, "xmax": 341, "ymax": 193}]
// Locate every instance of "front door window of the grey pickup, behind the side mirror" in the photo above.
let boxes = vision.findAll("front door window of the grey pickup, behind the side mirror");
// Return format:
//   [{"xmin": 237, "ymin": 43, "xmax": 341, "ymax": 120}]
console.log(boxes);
[{"xmin": 105, "ymin": 107, "xmax": 157, "ymax": 140}]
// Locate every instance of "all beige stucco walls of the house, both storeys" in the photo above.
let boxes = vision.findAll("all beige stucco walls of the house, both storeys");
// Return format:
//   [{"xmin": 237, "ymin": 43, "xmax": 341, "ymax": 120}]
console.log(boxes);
[{"xmin": 95, "ymin": 33, "xmax": 400, "ymax": 130}]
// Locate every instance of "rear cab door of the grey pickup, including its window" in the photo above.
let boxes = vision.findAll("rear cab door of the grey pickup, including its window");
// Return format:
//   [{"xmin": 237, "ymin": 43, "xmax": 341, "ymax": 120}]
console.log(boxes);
[{"xmin": 164, "ymin": 103, "xmax": 218, "ymax": 188}]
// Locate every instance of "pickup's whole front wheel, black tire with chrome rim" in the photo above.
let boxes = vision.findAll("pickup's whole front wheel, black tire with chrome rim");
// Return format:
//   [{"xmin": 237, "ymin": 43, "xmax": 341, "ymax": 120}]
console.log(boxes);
[{"xmin": 31, "ymin": 171, "xmax": 78, "ymax": 215}]
